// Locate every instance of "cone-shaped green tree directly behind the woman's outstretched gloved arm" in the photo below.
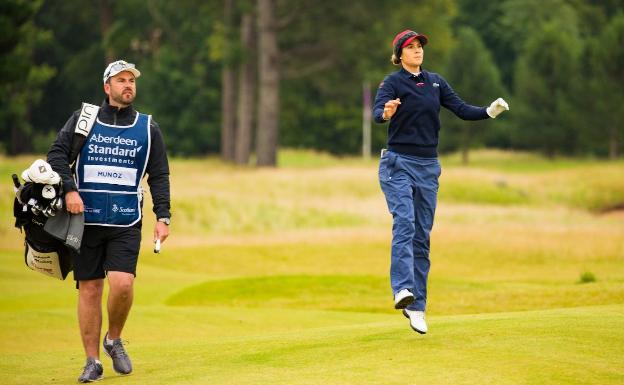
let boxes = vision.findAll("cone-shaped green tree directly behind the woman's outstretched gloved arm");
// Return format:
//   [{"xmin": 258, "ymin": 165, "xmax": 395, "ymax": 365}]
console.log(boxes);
[{"xmin": 441, "ymin": 27, "xmax": 508, "ymax": 164}]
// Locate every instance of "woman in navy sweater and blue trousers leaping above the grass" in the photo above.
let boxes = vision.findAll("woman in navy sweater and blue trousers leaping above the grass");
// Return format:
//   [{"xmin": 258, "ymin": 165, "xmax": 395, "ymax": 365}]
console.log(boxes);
[{"xmin": 373, "ymin": 30, "xmax": 509, "ymax": 334}]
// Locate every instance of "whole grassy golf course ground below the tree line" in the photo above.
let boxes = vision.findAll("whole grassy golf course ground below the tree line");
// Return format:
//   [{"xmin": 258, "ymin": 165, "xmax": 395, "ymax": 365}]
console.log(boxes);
[{"xmin": 0, "ymin": 151, "xmax": 624, "ymax": 385}]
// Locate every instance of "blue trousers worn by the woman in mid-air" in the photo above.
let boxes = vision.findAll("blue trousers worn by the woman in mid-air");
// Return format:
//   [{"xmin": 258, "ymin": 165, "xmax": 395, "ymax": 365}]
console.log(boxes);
[{"xmin": 379, "ymin": 151, "xmax": 441, "ymax": 311}]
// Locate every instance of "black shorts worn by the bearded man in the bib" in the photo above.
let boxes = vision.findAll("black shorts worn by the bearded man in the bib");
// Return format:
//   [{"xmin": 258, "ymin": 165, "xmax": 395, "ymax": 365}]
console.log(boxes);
[{"xmin": 74, "ymin": 221, "xmax": 141, "ymax": 281}]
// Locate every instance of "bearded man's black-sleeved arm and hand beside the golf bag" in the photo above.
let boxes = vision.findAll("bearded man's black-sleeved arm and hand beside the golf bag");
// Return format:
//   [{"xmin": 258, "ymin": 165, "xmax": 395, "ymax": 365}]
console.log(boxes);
[{"xmin": 48, "ymin": 111, "xmax": 84, "ymax": 214}]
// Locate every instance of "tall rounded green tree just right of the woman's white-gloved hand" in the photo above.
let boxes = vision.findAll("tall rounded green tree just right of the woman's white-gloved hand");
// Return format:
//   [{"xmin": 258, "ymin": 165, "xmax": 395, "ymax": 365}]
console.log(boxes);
[{"xmin": 512, "ymin": 21, "xmax": 582, "ymax": 157}]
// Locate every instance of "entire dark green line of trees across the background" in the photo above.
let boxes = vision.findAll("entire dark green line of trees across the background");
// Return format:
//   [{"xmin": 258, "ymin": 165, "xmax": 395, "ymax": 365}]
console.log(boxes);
[{"xmin": 0, "ymin": 0, "xmax": 624, "ymax": 166}]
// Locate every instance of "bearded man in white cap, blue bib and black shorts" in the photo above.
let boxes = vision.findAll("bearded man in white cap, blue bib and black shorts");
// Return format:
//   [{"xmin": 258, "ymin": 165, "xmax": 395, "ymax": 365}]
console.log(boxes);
[{"xmin": 48, "ymin": 60, "xmax": 171, "ymax": 382}]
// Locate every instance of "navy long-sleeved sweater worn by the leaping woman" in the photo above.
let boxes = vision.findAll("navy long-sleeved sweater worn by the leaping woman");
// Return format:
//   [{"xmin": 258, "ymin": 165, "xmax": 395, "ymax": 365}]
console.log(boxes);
[{"xmin": 373, "ymin": 68, "xmax": 489, "ymax": 158}]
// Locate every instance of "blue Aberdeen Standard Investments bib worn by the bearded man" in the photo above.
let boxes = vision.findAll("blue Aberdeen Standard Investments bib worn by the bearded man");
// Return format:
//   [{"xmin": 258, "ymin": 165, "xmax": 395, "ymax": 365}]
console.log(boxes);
[{"xmin": 76, "ymin": 112, "xmax": 151, "ymax": 226}]
